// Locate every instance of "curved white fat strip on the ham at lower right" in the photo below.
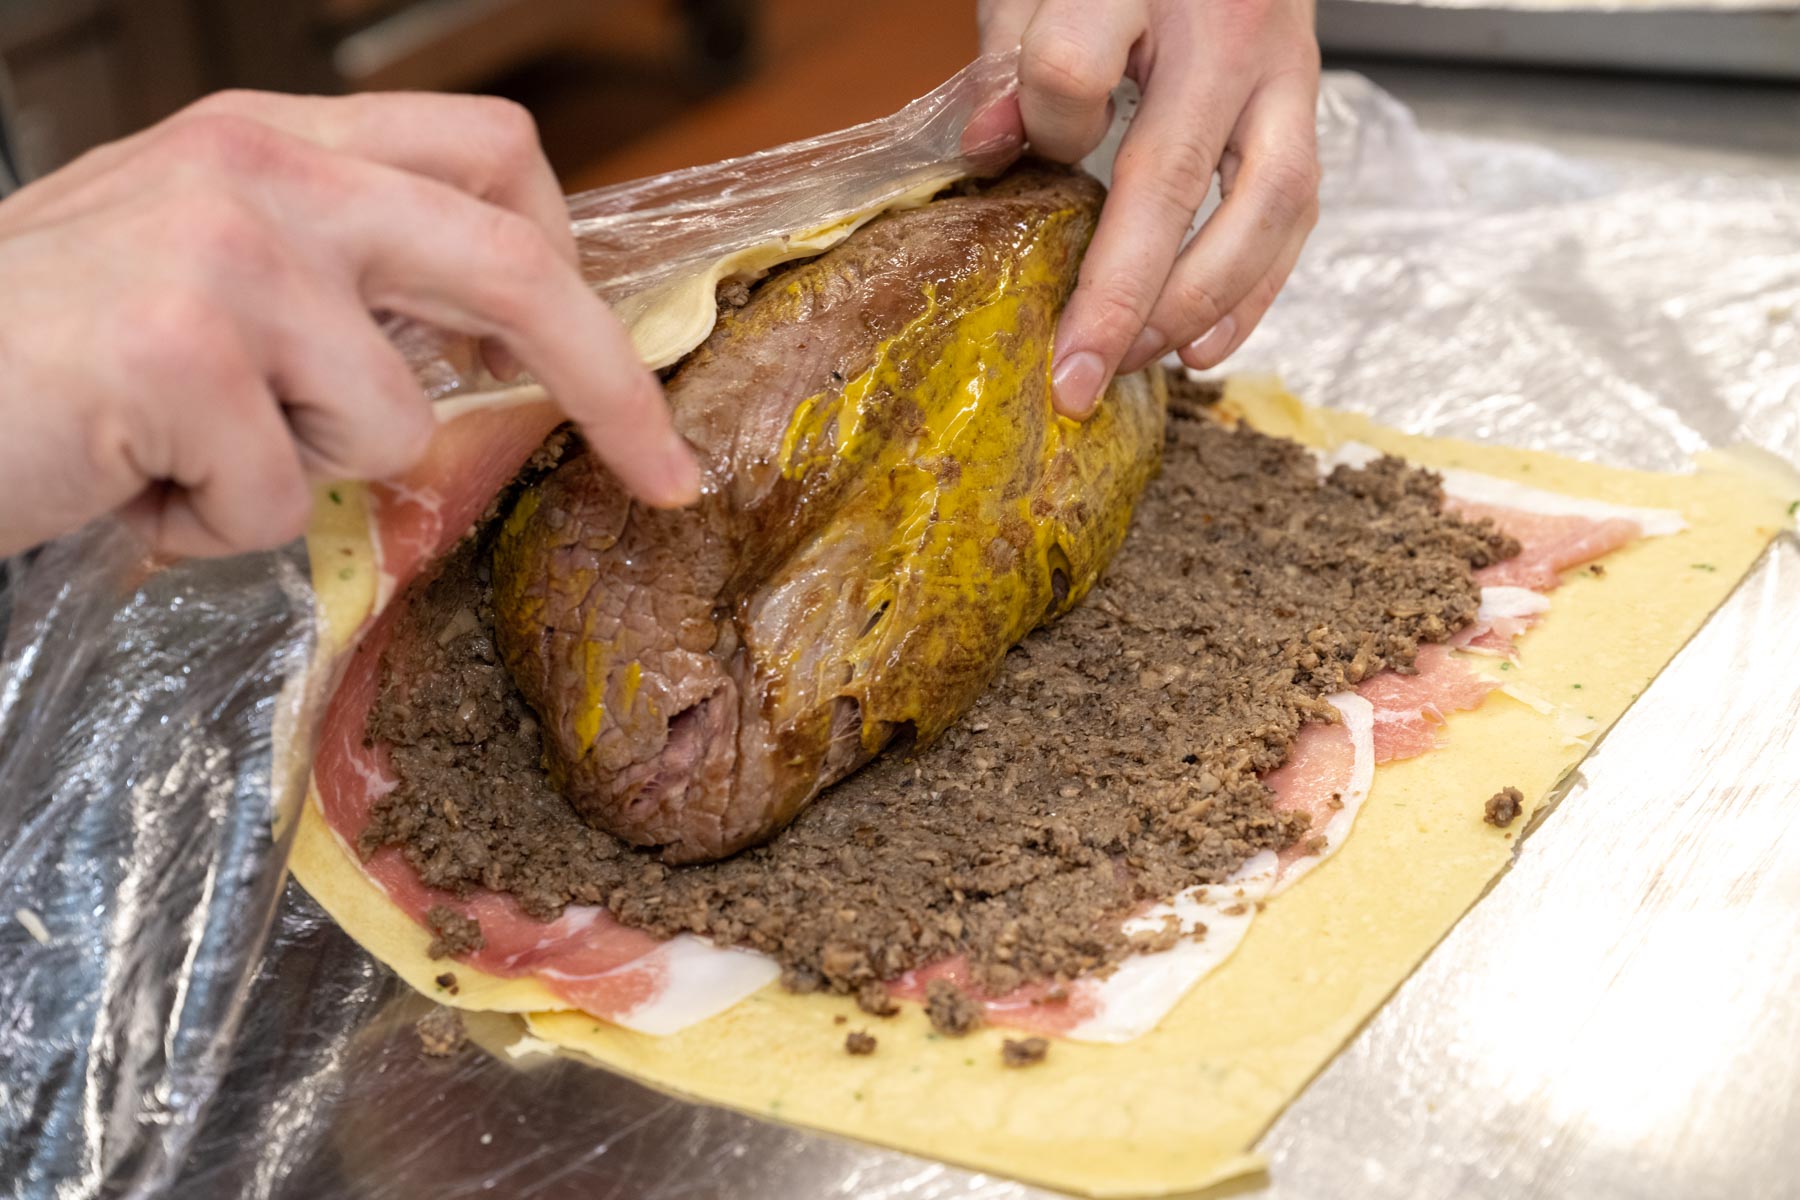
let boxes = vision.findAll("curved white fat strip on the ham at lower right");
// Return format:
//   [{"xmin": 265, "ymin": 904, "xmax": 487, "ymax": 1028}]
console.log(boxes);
[{"xmin": 1064, "ymin": 691, "xmax": 1375, "ymax": 1042}]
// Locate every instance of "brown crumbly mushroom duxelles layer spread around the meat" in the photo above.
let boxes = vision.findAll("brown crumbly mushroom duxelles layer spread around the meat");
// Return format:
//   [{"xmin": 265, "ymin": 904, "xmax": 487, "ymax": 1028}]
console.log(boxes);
[{"xmin": 369, "ymin": 380, "xmax": 1517, "ymax": 1015}]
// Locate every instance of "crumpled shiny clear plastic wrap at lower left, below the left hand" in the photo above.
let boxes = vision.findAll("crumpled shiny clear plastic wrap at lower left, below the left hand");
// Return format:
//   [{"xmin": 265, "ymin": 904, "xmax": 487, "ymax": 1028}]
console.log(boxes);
[{"xmin": 0, "ymin": 522, "xmax": 311, "ymax": 1196}]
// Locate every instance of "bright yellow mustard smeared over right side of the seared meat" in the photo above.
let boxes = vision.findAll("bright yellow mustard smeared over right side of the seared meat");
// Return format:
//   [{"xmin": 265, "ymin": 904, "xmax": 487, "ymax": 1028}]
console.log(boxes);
[{"xmin": 763, "ymin": 210, "xmax": 1163, "ymax": 750}]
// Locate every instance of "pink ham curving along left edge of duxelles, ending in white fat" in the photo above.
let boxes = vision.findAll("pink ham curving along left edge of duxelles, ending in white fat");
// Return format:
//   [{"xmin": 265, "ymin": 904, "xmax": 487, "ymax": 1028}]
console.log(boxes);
[{"xmin": 313, "ymin": 403, "xmax": 779, "ymax": 1034}]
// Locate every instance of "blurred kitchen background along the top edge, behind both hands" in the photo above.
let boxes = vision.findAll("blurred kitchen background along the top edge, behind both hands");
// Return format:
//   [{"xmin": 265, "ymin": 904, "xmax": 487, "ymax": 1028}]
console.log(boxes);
[{"xmin": 0, "ymin": 0, "xmax": 1800, "ymax": 191}]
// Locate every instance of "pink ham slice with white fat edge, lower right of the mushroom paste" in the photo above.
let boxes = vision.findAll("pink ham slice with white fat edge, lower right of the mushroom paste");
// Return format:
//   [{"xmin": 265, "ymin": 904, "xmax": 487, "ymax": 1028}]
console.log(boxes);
[{"xmin": 891, "ymin": 693, "xmax": 1375, "ymax": 1042}]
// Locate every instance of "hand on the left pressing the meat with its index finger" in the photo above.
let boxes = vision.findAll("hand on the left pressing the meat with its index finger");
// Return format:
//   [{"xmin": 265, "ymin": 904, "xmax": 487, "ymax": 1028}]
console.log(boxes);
[{"xmin": 0, "ymin": 92, "xmax": 698, "ymax": 556}]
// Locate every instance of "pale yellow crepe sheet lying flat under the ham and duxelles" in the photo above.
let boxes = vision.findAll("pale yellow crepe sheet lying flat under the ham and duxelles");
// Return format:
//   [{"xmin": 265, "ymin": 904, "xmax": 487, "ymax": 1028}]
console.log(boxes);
[{"xmin": 295, "ymin": 368, "xmax": 1793, "ymax": 1196}]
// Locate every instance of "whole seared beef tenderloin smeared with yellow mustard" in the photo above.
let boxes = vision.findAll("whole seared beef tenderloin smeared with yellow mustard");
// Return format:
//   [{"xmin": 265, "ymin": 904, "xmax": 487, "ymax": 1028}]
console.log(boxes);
[{"xmin": 493, "ymin": 167, "xmax": 1165, "ymax": 864}]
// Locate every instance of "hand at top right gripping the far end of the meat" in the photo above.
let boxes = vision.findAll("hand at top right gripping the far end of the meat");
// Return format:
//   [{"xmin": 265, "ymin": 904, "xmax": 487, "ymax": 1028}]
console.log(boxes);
[{"xmin": 979, "ymin": 0, "xmax": 1319, "ymax": 417}]
